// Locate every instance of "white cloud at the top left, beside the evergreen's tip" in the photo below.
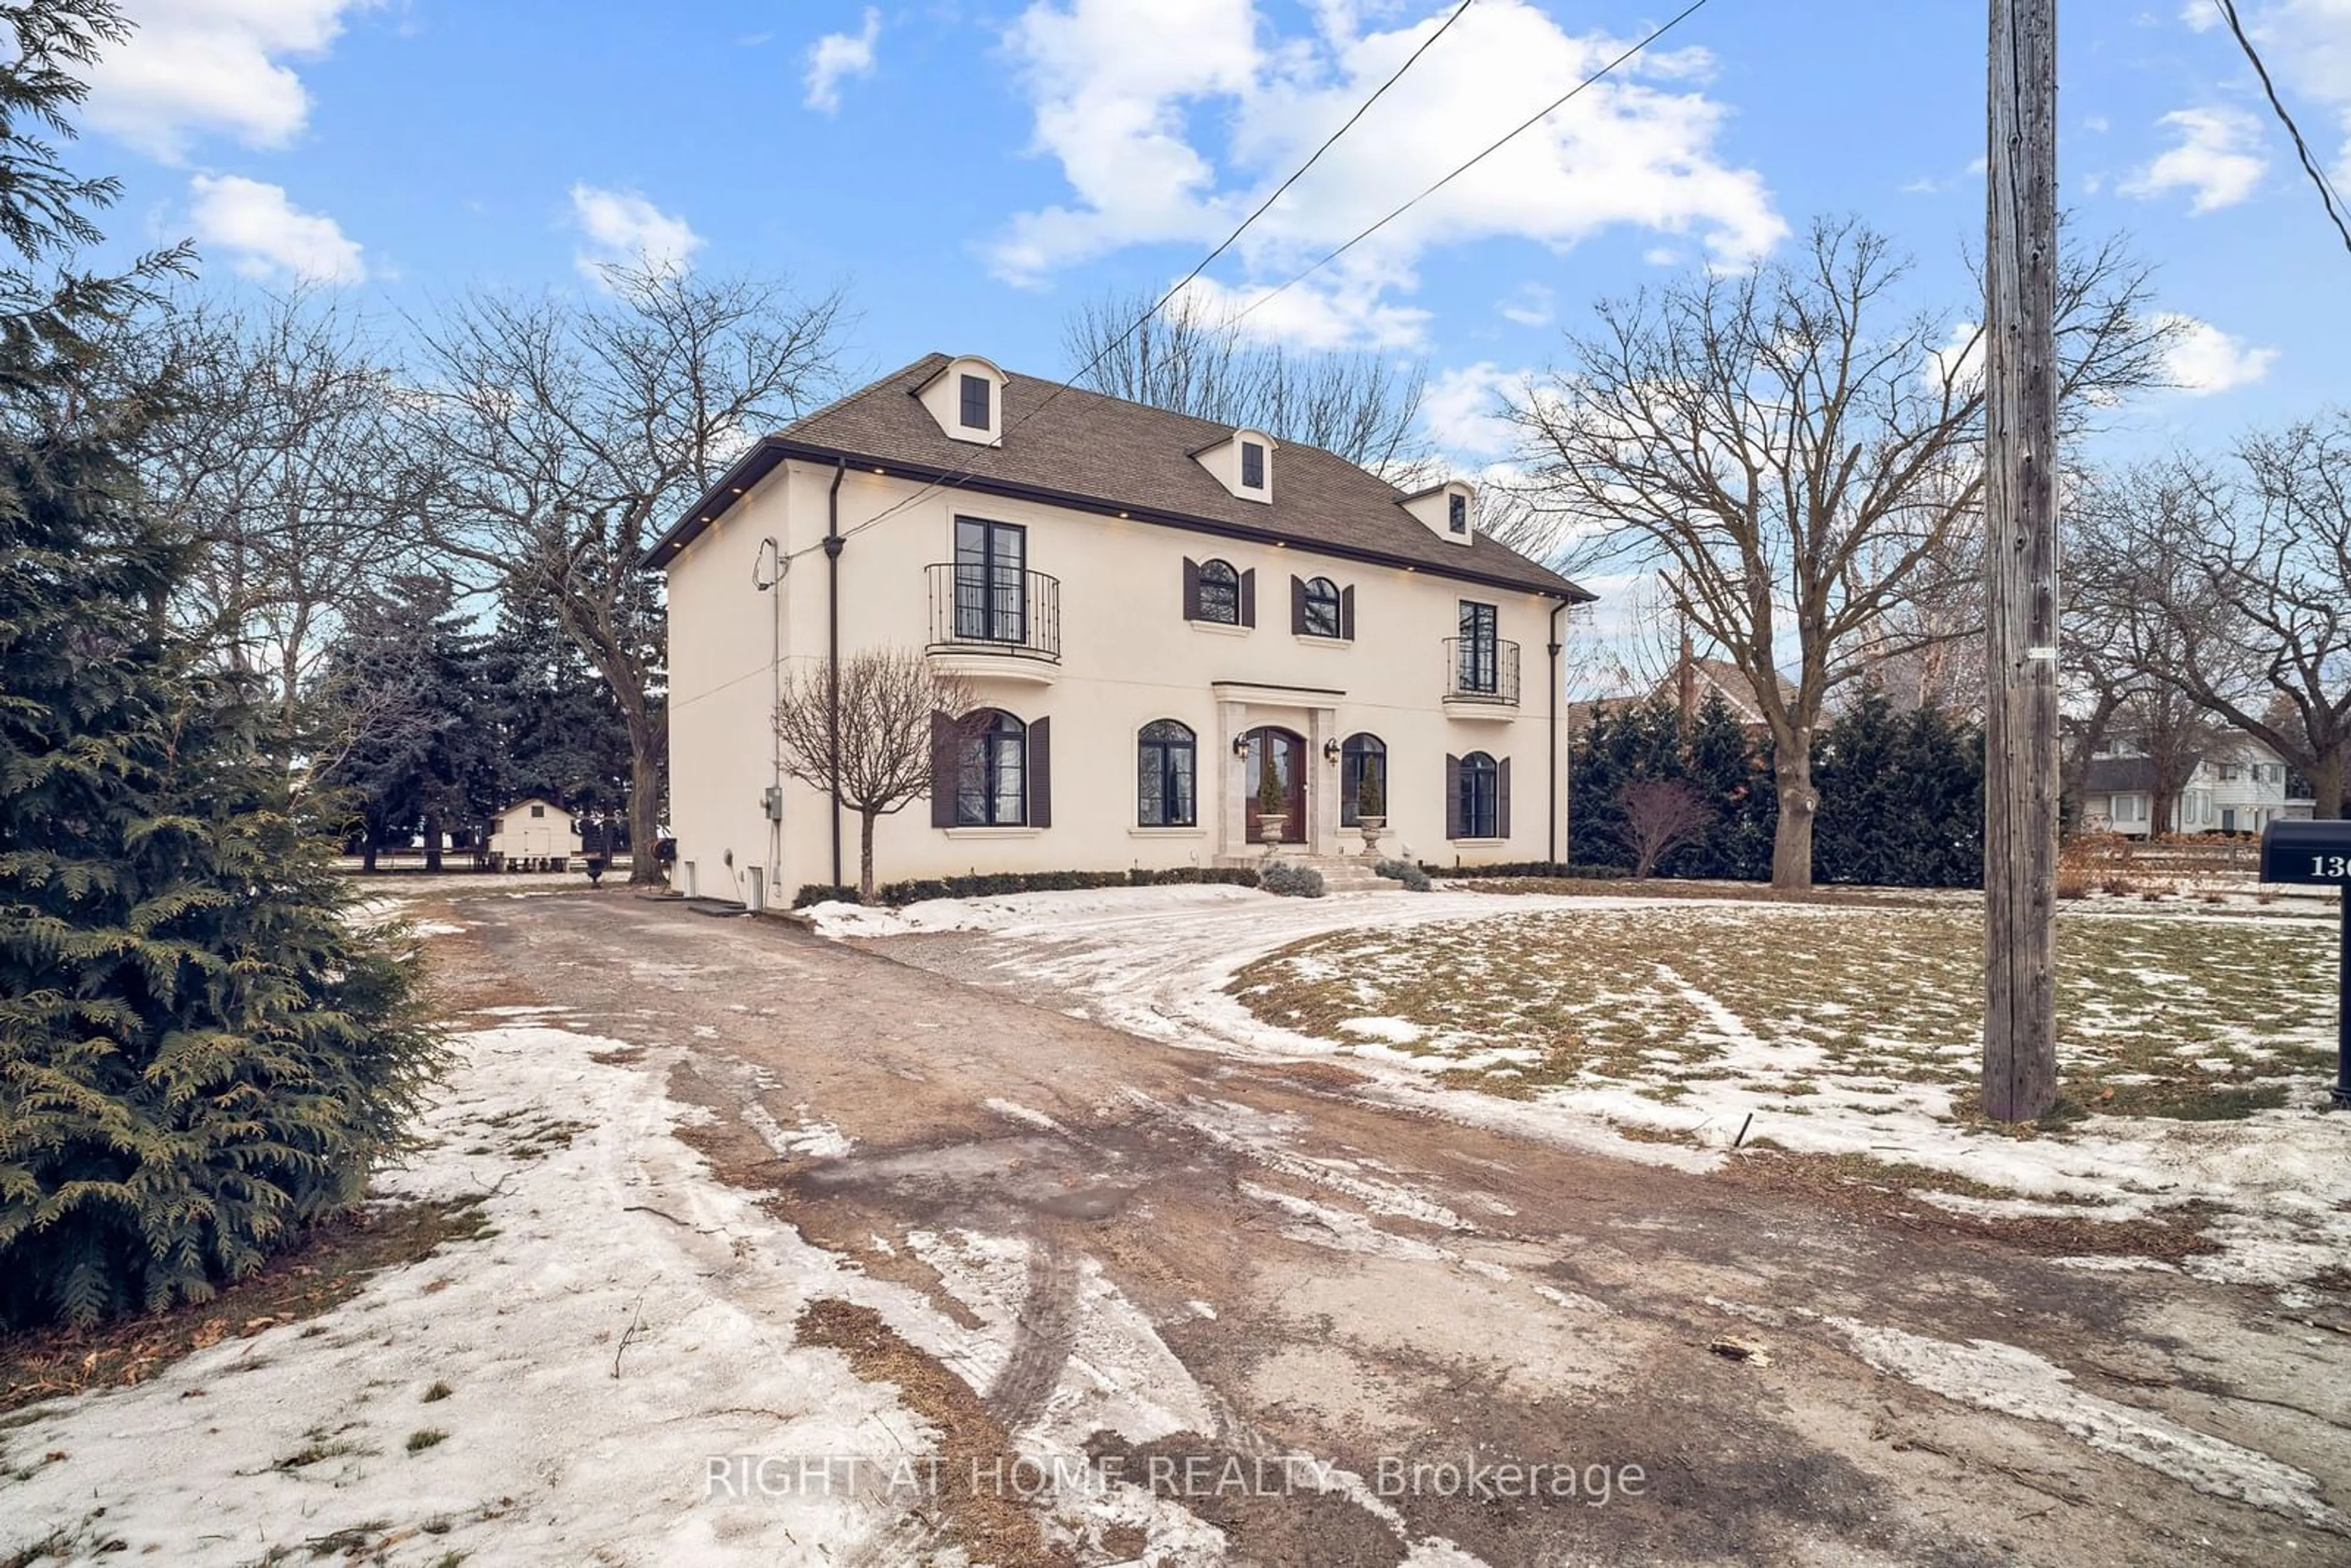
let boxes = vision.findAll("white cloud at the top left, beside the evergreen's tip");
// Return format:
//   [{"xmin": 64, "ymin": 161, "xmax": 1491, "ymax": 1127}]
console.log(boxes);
[{"xmin": 87, "ymin": 0, "xmax": 374, "ymax": 162}]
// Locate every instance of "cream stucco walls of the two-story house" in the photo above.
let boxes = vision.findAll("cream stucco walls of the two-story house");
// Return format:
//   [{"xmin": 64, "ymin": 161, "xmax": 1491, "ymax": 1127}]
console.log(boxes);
[{"xmin": 670, "ymin": 461, "xmax": 1564, "ymax": 901}]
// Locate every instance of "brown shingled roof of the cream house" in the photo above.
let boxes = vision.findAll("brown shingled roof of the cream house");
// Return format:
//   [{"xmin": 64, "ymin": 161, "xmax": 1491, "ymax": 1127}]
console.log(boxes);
[{"xmin": 644, "ymin": 355, "xmax": 1592, "ymax": 599}]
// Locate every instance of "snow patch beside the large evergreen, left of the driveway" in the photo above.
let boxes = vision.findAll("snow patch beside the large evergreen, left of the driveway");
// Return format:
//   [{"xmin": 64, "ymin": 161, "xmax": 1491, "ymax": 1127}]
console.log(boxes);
[{"xmin": 0, "ymin": 1022, "xmax": 926, "ymax": 1568}]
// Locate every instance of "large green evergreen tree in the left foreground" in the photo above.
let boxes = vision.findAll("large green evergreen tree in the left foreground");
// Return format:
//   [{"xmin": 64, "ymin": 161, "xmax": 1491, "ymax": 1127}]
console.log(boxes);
[{"xmin": 0, "ymin": 0, "xmax": 437, "ymax": 1328}]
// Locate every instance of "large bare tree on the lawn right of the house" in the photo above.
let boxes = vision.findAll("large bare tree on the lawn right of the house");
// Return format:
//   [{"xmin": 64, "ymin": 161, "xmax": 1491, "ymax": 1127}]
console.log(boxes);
[{"xmin": 1512, "ymin": 221, "xmax": 2165, "ymax": 888}]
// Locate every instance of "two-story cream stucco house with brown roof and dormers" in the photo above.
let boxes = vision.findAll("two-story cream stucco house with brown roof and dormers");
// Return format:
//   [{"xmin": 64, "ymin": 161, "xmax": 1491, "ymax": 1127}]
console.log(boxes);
[{"xmin": 647, "ymin": 355, "xmax": 1592, "ymax": 905}]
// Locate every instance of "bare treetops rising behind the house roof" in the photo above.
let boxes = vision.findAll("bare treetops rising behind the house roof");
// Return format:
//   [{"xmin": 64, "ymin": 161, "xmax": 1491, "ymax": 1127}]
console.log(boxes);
[{"xmin": 1063, "ymin": 294, "xmax": 1427, "ymax": 479}]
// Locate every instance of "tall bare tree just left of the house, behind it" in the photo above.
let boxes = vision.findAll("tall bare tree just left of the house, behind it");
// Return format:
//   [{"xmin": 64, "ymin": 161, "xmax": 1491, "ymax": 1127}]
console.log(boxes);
[{"xmin": 416, "ymin": 268, "xmax": 842, "ymax": 882}]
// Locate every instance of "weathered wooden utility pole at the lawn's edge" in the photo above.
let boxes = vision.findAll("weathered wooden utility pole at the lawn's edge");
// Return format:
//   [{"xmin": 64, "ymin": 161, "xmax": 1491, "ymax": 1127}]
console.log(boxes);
[{"xmin": 1984, "ymin": 0, "xmax": 2057, "ymax": 1121}]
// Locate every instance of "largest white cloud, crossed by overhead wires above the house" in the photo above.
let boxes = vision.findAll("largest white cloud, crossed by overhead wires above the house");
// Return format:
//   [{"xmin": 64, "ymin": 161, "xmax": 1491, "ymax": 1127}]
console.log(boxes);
[{"xmin": 990, "ymin": 0, "xmax": 1787, "ymax": 340}]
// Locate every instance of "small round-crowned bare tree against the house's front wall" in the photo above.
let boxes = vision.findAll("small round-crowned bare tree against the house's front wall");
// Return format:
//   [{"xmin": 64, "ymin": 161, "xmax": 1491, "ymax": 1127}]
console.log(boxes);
[{"xmin": 776, "ymin": 649, "xmax": 978, "ymax": 901}]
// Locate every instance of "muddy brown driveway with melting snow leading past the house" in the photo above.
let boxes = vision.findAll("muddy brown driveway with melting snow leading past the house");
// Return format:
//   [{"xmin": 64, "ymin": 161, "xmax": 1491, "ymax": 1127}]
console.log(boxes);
[{"xmin": 437, "ymin": 893, "xmax": 2351, "ymax": 1568}]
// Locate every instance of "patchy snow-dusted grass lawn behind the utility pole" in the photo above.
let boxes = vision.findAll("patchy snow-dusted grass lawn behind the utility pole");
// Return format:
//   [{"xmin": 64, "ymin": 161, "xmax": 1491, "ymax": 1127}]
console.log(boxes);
[{"xmin": 1232, "ymin": 905, "xmax": 2334, "ymax": 1119}]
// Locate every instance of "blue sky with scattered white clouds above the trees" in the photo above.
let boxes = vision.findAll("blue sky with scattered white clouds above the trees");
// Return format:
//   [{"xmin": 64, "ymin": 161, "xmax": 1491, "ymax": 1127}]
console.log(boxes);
[{"xmin": 75, "ymin": 0, "xmax": 2351, "ymax": 463}]
